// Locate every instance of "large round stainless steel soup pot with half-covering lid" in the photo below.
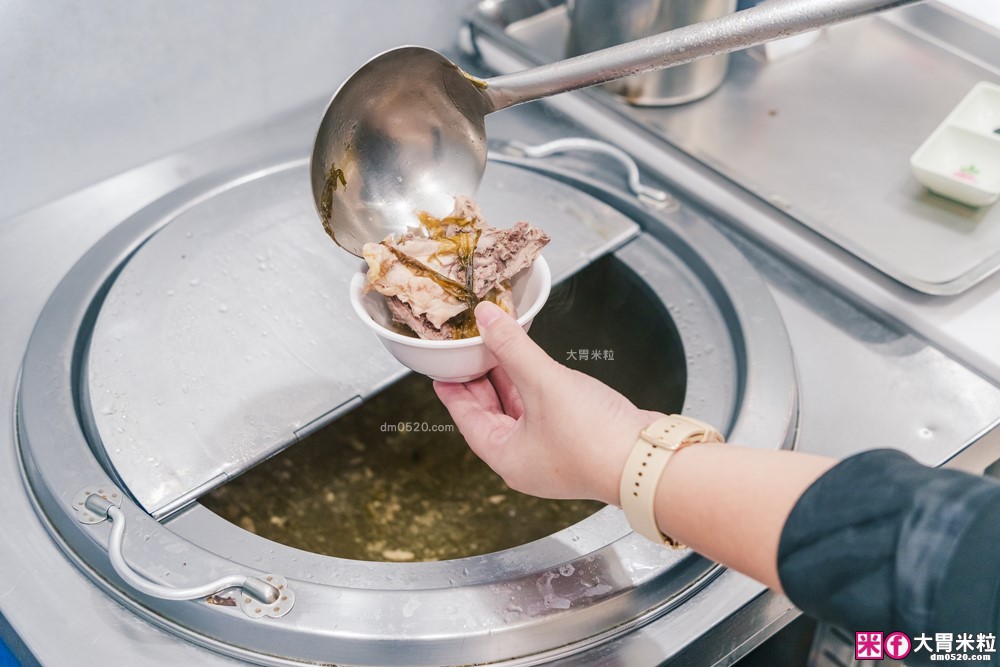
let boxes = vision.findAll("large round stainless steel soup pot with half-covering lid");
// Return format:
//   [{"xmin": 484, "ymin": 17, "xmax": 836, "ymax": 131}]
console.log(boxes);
[{"xmin": 17, "ymin": 131, "xmax": 797, "ymax": 666}]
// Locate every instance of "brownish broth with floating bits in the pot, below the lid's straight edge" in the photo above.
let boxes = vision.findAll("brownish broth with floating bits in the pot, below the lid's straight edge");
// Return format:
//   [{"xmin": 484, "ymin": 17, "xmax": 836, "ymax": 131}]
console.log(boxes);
[{"xmin": 202, "ymin": 375, "xmax": 603, "ymax": 562}]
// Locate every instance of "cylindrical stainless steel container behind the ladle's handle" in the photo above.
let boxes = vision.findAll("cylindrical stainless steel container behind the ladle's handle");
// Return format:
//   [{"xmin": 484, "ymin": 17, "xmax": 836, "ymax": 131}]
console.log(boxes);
[{"xmin": 566, "ymin": 0, "xmax": 736, "ymax": 106}]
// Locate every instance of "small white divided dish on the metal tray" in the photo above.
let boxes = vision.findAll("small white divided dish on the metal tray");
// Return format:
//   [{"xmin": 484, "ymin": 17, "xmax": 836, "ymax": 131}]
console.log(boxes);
[{"xmin": 910, "ymin": 81, "xmax": 1000, "ymax": 206}]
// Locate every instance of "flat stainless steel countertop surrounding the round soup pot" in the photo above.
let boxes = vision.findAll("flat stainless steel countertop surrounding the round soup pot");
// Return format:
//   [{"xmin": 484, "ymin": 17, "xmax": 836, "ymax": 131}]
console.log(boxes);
[{"xmin": 0, "ymin": 85, "xmax": 1000, "ymax": 664}]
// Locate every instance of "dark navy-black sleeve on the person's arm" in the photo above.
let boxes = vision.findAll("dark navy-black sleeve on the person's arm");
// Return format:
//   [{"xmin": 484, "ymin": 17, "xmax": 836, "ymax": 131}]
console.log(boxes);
[{"xmin": 778, "ymin": 450, "xmax": 1000, "ymax": 664}]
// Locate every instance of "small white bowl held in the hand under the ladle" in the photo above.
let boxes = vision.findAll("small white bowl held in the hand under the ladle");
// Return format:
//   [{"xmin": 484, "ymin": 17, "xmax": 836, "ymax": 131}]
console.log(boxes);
[{"xmin": 350, "ymin": 257, "xmax": 552, "ymax": 382}]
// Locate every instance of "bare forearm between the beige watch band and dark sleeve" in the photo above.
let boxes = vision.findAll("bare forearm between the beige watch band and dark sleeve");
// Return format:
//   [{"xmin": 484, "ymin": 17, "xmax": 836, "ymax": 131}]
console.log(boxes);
[{"xmin": 644, "ymin": 444, "xmax": 835, "ymax": 591}]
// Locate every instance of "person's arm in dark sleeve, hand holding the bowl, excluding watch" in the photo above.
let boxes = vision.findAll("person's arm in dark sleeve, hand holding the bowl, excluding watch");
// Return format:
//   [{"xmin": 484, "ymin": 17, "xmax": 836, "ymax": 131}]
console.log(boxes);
[{"xmin": 442, "ymin": 302, "xmax": 1000, "ymax": 636}]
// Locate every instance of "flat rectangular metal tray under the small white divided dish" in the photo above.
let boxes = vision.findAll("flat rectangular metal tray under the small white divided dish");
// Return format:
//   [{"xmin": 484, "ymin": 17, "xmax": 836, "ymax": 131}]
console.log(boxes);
[{"xmin": 466, "ymin": 0, "xmax": 1000, "ymax": 295}]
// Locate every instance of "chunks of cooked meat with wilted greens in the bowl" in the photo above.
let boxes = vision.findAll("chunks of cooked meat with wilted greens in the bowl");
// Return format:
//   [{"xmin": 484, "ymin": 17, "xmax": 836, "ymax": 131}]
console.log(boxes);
[{"xmin": 362, "ymin": 197, "xmax": 549, "ymax": 340}]
